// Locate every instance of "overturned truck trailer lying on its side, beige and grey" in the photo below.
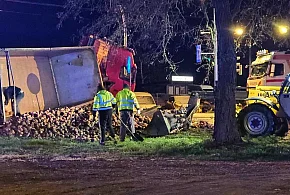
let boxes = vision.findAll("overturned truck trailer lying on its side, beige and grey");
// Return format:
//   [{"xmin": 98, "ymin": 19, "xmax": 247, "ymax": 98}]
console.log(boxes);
[{"xmin": 0, "ymin": 47, "xmax": 101, "ymax": 119}]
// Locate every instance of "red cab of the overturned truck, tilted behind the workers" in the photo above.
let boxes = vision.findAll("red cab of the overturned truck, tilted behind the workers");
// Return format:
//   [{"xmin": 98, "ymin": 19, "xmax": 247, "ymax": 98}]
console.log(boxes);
[{"xmin": 80, "ymin": 35, "xmax": 137, "ymax": 95}]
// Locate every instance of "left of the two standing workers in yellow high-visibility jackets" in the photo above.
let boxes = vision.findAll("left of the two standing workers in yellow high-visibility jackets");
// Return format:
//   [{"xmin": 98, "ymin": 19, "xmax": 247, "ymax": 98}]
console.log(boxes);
[{"xmin": 93, "ymin": 84, "xmax": 116, "ymax": 145}]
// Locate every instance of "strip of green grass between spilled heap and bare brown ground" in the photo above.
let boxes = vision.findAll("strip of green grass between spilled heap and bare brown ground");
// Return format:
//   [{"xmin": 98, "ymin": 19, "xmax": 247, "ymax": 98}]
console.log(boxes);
[{"xmin": 0, "ymin": 131, "xmax": 290, "ymax": 161}]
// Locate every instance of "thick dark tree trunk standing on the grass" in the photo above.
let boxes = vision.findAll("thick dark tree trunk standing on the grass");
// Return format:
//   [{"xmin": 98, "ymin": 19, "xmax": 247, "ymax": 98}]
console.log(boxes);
[{"xmin": 213, "ymin": 0, "xmax": 241, "ymax": 144}]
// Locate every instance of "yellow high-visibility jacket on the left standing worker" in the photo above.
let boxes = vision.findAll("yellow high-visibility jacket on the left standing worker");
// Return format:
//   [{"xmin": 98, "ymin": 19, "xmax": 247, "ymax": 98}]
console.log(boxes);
[{"xmin": 93, "ymin": 90, "xmax": 116, "ymax": 111}]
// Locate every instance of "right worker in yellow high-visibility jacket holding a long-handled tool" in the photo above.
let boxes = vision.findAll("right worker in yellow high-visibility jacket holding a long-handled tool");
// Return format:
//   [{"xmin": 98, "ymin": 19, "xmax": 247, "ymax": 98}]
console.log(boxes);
[{"xmin": 116, "ymin": 84, "xmax": 140, "ymax": 142}]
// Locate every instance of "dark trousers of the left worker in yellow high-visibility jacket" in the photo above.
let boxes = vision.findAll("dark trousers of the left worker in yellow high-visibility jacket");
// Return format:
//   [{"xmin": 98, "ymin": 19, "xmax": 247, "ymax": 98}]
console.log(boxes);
[{"xmin": 99, "ymin": 109, "xmax": 115, "ymax": 142}]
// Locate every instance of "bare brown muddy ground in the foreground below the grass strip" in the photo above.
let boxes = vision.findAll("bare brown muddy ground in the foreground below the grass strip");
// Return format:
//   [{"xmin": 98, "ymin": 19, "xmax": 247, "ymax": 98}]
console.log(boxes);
[{"xmin": 0, "ymin": 154, "xmax": 290, "ymax": 195}]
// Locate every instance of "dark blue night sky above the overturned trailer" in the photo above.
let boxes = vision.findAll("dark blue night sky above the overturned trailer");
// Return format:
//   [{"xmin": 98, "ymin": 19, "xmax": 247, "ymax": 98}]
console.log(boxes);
[{"xmin": 0, "ymin": 0, "xmax": 79, "ymax": 48}]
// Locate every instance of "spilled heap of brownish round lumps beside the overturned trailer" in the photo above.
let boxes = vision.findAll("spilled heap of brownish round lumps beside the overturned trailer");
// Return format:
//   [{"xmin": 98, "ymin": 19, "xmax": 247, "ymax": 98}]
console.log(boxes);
[{"xmin": 0, "ymin": 105, "xmax": 212, "ymax": 141}]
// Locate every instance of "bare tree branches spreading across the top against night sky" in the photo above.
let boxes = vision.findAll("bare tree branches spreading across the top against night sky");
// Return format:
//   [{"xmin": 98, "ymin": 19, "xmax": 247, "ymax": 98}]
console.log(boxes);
[{"xmin": 59, "ymin": 0, "xmax": 290, "ymax": 84}]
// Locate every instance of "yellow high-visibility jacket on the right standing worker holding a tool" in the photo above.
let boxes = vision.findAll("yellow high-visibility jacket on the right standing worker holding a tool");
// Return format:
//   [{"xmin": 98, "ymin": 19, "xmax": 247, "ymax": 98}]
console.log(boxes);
[{"xmin": 116, "ymin": 88, "xmax": 139, "ymax": 110}]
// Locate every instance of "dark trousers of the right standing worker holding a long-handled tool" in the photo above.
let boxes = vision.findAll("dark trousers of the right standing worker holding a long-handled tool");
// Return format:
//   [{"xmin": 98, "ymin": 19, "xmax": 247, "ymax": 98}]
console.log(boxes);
[{"xmin": 120, "ymin": 110, "xmax": 135, "ymax": 141}]
